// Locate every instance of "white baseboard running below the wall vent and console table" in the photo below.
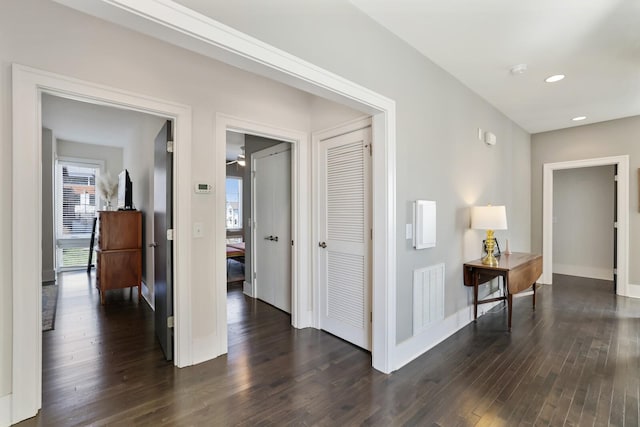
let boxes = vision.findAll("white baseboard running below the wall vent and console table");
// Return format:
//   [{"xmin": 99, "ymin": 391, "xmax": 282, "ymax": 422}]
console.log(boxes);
[{"xmin": 393, "ymin": 289, "xmax": 502, "ymax": 370}]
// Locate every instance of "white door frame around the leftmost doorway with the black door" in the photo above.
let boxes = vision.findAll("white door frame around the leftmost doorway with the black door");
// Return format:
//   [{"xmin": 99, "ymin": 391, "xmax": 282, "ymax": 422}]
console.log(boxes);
[{"xmin": 11, "ymin": 64, "xmax": 192, "ymax": 423}]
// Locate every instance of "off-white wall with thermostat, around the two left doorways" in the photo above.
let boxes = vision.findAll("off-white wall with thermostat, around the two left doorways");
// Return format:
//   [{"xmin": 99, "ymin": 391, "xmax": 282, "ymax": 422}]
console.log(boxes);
[{"xmin": 0, "ymin": 0, "xmax": 368, "ymax": 397}]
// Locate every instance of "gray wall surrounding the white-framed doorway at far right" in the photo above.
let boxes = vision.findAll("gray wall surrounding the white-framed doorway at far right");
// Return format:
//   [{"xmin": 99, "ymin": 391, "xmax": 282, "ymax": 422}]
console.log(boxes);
[{"xmin": 531, "ymin": 116, "xmax": 640, "ymax": 284}]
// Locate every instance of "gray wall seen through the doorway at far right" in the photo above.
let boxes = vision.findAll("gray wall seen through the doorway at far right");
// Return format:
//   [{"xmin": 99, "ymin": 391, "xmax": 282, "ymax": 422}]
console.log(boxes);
[{"xmin": 553, "ymin": 165, "xmax": 615, "ymax": 280}]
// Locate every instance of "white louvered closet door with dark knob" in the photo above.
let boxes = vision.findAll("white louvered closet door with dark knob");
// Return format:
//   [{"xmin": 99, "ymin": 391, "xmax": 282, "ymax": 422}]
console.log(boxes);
[{"xmin": 318, "ymin": 128, "xmax": 371, "ymax": 350}]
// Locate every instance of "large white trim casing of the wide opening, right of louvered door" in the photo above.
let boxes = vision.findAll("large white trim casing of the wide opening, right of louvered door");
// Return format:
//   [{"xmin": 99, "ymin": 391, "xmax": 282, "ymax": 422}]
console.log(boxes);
[{"xmin": 55, "ymin": 0, "xmax": 396, "ymax": 373}]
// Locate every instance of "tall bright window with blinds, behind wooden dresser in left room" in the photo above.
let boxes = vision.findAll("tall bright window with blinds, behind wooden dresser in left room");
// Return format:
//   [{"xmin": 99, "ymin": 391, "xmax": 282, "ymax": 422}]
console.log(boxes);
[{"xmin": 55, "ymin": 160, "xmax": 101, "ymax": 269}]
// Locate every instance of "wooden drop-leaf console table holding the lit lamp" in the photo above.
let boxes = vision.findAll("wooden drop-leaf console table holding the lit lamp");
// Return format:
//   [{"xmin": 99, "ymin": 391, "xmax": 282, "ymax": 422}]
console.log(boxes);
[{"xmin": 464, "ymin": 252, "xmax": 542, "ymax": 329}]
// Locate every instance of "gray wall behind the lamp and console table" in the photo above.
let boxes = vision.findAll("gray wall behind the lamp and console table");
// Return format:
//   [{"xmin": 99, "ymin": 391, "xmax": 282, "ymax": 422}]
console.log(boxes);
[{"xmin": 174, "ymin": 0, "xmax": 531, "ymax": 342}]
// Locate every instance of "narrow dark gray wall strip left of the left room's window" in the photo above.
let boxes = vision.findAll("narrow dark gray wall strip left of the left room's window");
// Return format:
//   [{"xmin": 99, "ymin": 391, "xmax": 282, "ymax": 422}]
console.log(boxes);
[{"xmin": 42, "ymin": 128, "xmax": 56, "ymax": 282}]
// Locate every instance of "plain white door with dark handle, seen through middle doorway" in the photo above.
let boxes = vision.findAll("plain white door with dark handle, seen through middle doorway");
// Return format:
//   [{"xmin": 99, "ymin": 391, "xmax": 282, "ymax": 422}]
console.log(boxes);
[{"xmin": 251, "ymin": 143, "xmax": 291, "ymax": 313}]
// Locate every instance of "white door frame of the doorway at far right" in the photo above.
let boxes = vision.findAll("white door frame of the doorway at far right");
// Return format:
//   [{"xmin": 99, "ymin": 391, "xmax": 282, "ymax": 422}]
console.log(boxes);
[{"xmin": 542, "ymin": 155, "xmax": 630, "ymax": 296}]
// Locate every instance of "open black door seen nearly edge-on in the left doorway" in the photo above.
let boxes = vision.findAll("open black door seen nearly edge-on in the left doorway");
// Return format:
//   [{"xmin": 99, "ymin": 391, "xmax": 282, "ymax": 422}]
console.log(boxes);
[{"xmin": 153, "ymin": 120, "xmax": 173, "ymax": 360}]
